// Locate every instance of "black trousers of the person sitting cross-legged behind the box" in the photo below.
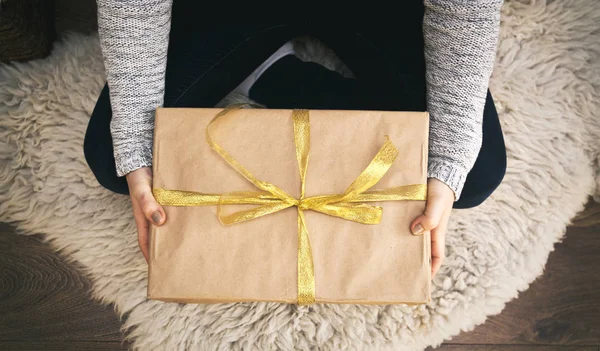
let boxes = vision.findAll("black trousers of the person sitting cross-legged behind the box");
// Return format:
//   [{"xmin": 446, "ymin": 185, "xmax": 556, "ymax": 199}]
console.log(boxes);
[{"xmin": 84, "ymin": 4, "xmax": 506, "ymax": 208}]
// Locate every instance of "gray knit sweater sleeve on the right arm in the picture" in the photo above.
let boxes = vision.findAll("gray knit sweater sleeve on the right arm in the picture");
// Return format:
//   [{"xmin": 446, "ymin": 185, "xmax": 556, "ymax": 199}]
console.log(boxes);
[{"xmin": 423, "ymin": 0, "xmax": 503, "ymax": 201}]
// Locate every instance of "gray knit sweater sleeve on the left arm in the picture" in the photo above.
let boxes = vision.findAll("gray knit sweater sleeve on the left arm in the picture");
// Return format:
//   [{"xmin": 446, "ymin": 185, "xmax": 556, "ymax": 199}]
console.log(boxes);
[{"xmin": 97, "ymin": 0, "xmax": 172, "ymax": 176}]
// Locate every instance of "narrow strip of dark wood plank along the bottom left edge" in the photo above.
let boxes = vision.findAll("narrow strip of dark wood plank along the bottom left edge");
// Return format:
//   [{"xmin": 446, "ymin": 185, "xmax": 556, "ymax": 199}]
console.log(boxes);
[{"xmin": 0, "ymin": 341, "xmax": 127, "ymax": 351}]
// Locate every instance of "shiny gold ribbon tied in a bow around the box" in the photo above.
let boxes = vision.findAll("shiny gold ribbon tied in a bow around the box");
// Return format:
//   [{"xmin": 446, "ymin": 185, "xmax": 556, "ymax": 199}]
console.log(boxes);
[{"xmin": 153, "ymin": 104, "xmax": 427, "ymax": 305}]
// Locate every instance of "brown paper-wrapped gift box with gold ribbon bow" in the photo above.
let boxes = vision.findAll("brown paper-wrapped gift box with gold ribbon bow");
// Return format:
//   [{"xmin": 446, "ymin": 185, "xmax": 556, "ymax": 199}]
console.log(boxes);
[{"xmin": 148, "ymin": 105, "xmax": 431, "ymax": 305}]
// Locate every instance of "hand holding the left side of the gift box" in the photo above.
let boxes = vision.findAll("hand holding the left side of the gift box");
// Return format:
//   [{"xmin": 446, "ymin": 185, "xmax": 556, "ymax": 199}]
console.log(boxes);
[{"xmin": 125, "ymin": 167, "xmax": 167, "ymax": 262}]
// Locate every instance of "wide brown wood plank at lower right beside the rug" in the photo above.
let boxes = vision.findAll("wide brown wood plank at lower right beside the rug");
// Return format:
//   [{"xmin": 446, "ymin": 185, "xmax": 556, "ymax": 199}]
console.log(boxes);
[{"xmin": 448, "ymin": 221, "xmax": 600, "ymax": 345}]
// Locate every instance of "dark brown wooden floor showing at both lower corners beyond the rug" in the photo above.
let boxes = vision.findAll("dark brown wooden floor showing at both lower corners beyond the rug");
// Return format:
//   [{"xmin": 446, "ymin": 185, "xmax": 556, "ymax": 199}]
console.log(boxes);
[{"xmin": 0, "ymin": 199, "xmax": 600, "ymax": 351}]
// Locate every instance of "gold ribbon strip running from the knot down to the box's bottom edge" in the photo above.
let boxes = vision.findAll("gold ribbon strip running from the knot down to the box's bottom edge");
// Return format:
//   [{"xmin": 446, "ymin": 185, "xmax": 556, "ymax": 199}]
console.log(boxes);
[{"xmin": 298, "ymin": 209, "xmax": 315, "ymax": 305}]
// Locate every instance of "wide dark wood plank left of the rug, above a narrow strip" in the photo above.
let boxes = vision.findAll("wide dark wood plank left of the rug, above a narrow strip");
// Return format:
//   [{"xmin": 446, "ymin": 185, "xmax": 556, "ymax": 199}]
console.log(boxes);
[{"xmin": 0, "ymin": 225, "xmax": 123, "ymax": 343}]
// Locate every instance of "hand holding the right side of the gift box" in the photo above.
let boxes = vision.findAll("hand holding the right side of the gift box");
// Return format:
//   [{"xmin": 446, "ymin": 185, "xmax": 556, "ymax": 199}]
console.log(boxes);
[{"xmin": 410, "ymin": 178, "xmax": 454, "ymax": 278}]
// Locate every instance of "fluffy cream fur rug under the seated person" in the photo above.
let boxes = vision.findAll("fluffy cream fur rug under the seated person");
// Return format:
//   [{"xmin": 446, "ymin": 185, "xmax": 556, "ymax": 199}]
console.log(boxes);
[{"xmin": 0, "ymin": 0, "xmax": 600, "ymax": 350}]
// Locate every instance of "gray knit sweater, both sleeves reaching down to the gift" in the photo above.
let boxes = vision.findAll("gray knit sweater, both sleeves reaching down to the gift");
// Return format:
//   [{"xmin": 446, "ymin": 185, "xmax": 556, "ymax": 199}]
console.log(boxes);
[{"xmin": 97, "ymin": 0, "xmax": 503, "ymax": 200}]
